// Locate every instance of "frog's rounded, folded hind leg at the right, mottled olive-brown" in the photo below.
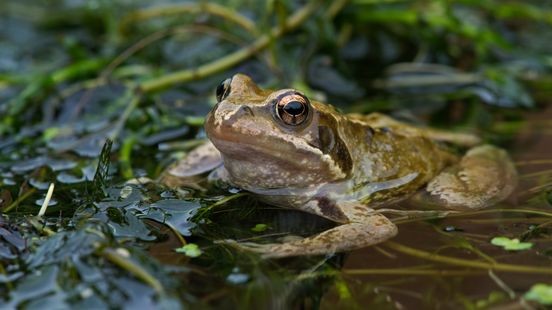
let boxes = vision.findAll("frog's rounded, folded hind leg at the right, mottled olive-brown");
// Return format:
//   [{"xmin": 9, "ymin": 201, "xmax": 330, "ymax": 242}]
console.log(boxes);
[{"xmin": 416, "ymin": 145, "xmax": 517, "ymax": 210}]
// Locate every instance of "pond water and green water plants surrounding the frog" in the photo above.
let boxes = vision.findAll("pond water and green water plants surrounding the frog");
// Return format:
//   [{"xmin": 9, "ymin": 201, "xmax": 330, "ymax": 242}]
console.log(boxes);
[{"xmin": 0, "ymin": 0, "xmax": 552, "ymax": 309}]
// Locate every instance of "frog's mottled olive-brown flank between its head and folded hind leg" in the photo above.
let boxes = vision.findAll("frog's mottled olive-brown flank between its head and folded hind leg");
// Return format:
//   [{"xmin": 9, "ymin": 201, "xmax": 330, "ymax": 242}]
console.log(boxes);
[{"xmin": 341, "ymin": 115, "xmax": 456, "ymax": 203}]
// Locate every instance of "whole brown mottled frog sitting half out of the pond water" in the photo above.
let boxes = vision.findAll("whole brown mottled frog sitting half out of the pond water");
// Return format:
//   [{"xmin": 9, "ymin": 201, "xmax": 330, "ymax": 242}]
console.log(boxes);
[{"xmin": 161, "ymin": 73, "xmax": 517, "ymax": 258}]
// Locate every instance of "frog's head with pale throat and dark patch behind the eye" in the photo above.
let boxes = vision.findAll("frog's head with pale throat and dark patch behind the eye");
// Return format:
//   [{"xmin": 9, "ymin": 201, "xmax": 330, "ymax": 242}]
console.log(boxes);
[{"xmin": 205, "ymin": 74, "xmax": 352, "ymax": 189}]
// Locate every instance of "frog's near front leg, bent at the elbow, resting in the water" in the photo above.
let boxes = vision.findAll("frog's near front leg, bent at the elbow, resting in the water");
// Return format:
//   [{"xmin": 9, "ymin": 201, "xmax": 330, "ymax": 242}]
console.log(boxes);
[{"xmin": 225, "ymin": 198, "xmax": 397, "ymax": 258}]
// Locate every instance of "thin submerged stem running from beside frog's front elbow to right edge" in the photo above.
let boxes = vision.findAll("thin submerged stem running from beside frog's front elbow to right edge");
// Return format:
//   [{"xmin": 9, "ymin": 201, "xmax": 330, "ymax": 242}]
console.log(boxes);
[{"xmin": 384, "ymin": 241, "xmax": 552, "ymax": 274}]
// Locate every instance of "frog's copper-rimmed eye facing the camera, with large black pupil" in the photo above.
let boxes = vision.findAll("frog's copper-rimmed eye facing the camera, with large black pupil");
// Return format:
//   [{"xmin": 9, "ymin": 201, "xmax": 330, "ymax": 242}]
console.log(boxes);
[{"xmin": 276, "ymin": 92, "xmax": 309, "ymax": 126}]
